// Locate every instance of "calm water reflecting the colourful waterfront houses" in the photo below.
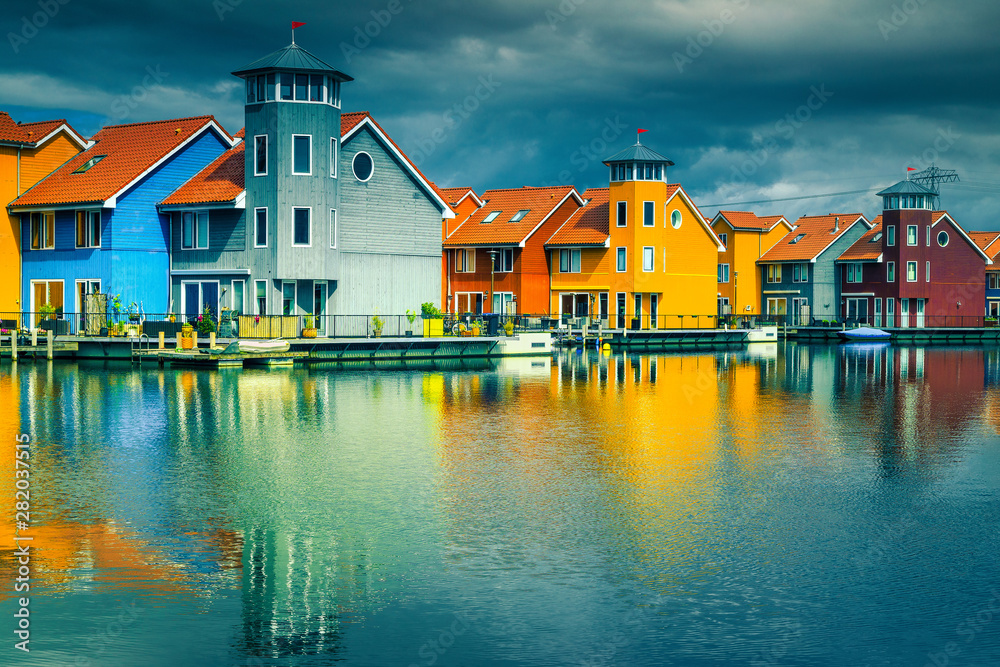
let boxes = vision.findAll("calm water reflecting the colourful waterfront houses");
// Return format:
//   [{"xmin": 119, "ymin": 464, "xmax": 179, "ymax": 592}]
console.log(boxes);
[{"xmin": 0, "ymin": 344, "xmax": 1000, "ymax": 667}]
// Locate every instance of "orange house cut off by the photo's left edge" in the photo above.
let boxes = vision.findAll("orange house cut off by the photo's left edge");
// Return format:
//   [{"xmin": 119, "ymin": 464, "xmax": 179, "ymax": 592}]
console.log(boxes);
[{"xmin": 0, "ymin": 111, "xmax": 90, "ymax": 319}]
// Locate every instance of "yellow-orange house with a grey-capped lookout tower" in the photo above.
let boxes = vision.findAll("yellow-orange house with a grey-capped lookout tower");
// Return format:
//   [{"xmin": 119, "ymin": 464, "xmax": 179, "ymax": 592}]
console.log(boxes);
[{"xmin": 547, "ymin": 143, "xmax": 725, "ymax": 329}]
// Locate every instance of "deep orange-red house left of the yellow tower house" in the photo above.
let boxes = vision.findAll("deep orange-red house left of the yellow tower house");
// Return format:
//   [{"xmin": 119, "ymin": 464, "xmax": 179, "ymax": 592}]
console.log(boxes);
[{"xmin": 443, "ymin": 185, "xmax": 583, "ymax": 314}]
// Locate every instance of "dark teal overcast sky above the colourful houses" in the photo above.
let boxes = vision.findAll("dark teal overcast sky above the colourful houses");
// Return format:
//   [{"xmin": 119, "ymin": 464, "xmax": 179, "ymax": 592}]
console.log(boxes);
[{"xmin": 0, "ymin": 0, "xmax": 1000, "ymax": 229}]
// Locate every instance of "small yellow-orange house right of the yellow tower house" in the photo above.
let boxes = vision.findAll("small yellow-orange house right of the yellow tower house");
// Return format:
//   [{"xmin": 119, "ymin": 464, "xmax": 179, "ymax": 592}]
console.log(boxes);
[{"xmin": 712, "ymin": 211, "xmax": 792, "ymax": 316}]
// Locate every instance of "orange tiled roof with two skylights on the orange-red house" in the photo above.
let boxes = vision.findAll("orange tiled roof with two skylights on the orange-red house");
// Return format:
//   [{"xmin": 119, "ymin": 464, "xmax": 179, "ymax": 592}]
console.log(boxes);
[{"xmin": 444, "ymin": 185, "xmax": 583, "ymax": 248}]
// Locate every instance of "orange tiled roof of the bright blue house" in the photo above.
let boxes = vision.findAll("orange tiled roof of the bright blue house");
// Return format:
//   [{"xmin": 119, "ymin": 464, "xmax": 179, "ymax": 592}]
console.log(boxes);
[{"xmin": 10, "ymin": 116, "xmax": 233, "ymax": 209}]
